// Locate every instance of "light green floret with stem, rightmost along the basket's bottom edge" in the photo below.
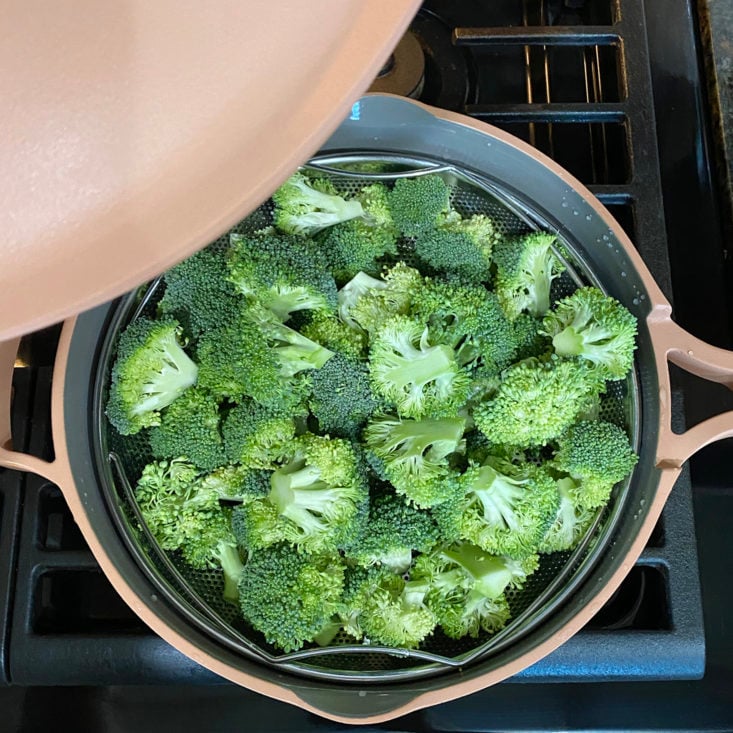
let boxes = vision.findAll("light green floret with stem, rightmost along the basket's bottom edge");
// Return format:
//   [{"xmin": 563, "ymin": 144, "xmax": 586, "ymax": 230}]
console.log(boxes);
[{"xmin": 410, "ymin": 550, "xmax": 510, "ymax": 639}]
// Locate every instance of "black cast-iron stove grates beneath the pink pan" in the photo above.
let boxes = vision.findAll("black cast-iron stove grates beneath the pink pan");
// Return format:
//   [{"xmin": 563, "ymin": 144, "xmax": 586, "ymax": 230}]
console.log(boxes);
[{"xmin": 0, "ymin": 0, "xmax": 705, "ymax": 685}]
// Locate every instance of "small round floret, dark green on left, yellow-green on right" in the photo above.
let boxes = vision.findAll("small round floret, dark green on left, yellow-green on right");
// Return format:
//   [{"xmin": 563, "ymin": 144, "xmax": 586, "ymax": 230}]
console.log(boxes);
[{"xmin": 222, "ymin": 400, "xmax": 296, "ymax": 469}]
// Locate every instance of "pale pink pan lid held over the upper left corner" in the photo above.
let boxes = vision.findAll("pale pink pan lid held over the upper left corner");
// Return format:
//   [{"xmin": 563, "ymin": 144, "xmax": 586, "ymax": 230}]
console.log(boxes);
[{"xmin": 0, "ymin": 0, "xmax": 419, "ymax": 340}]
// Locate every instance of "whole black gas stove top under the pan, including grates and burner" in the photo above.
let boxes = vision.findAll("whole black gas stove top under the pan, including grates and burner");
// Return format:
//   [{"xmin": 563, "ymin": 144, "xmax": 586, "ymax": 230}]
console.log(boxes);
[{"xmin": 0, "ymin": 0, "xmax": 733, "ymax": 731}]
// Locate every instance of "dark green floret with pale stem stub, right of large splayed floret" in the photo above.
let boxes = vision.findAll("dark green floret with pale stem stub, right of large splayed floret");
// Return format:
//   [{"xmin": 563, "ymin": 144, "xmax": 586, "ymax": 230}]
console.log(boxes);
[{"xmin": 346, "ymin": 493, "xmax": 440, "ymax": 573}]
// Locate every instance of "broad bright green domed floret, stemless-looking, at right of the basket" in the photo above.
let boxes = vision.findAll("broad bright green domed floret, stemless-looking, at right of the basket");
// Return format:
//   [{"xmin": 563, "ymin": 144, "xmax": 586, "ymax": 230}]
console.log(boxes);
[{"xmin": 473, "ymin": 359, "xmax": 604, "ymax": 448}]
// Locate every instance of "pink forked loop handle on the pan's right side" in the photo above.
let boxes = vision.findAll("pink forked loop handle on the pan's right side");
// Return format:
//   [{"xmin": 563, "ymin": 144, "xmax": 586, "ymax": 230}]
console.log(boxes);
[{"xmin": 647, "ymin": 304, "xmax": 733, "ymax": 469}]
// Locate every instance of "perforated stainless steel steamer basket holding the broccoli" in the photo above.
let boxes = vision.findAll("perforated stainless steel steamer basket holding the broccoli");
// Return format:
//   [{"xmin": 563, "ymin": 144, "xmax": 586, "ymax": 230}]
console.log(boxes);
[{"xmin": 94, "ymin": 154, "xmax": 639, "ymax": 683}]
